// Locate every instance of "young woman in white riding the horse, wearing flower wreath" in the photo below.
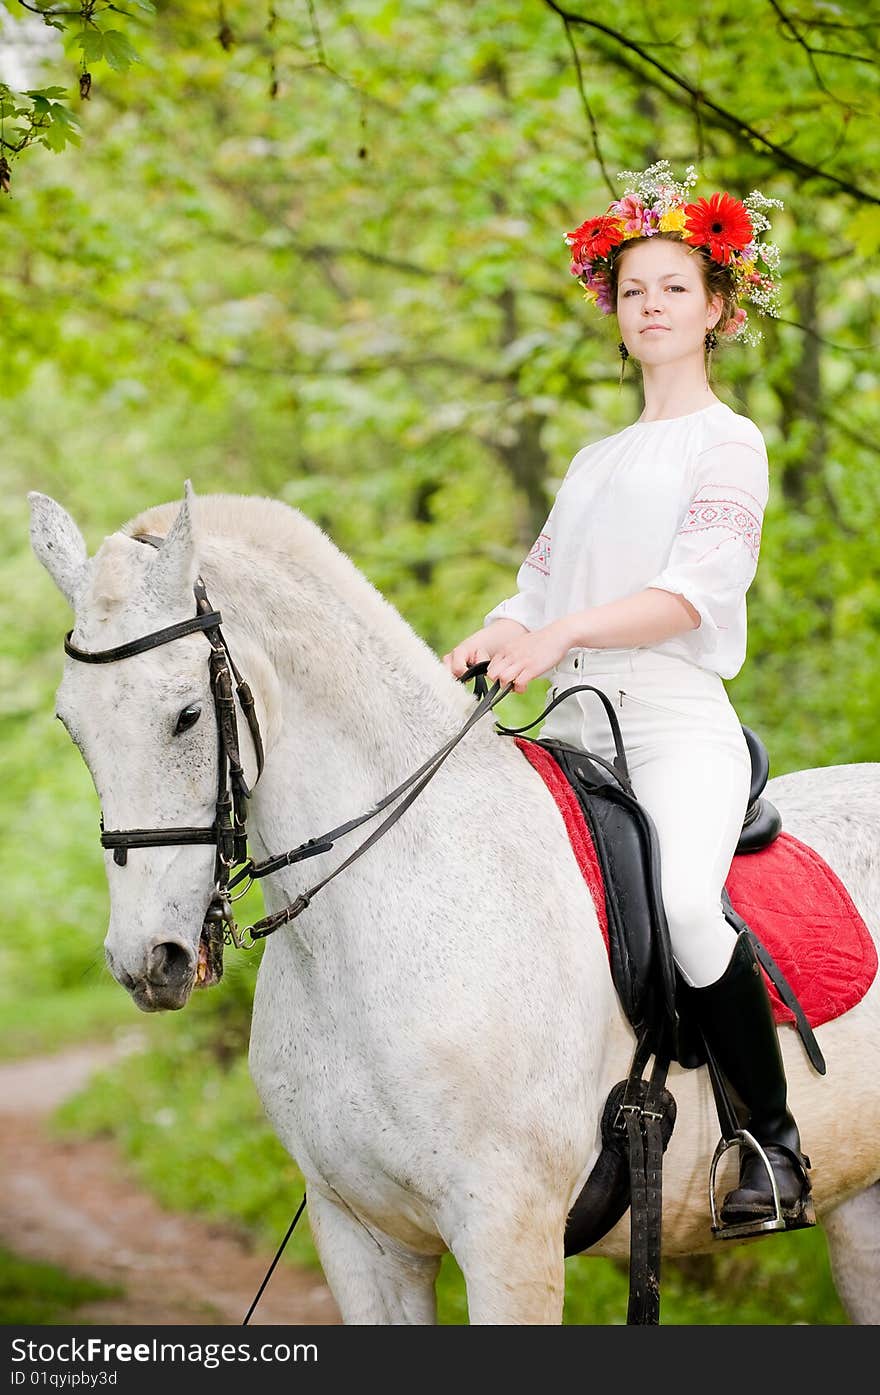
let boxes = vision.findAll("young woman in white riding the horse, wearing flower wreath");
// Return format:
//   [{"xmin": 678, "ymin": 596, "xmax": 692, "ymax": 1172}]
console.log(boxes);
[{"xmin": 443, "ymin": 160, "xmax": 813, "ymax": 1244}]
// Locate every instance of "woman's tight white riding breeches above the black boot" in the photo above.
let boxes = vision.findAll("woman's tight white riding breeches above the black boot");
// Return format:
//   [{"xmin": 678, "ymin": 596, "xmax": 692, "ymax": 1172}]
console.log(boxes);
[{"xmin": 541, "ymin": 649, "xmax": 752, "ymax": 988}]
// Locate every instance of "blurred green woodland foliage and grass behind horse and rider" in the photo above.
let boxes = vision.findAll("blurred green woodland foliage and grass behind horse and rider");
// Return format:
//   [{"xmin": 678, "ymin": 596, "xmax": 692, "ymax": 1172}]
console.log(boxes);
[{"xmin": 0, "ymin": 0, "xmax": 880, "ymax": 1324}]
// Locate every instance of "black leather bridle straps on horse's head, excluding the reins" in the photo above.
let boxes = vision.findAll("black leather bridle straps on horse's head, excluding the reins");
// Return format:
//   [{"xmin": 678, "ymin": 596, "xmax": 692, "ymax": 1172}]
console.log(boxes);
[{"xmin": 64, "ymin": 536, "xmax": 264, "ymax": 935}]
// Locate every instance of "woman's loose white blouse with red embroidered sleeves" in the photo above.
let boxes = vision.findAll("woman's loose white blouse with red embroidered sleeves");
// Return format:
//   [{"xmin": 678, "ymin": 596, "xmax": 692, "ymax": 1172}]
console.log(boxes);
[{"xmin": 485, "ymin": 402, "xmax": 770, "ymax": 678}]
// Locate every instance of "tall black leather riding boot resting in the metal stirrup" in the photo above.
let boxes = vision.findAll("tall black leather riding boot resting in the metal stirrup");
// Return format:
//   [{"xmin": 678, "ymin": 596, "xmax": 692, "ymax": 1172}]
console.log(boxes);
[{"xmin": 686, "ymin": 935, "xmax": 814, "ymax": 1226}]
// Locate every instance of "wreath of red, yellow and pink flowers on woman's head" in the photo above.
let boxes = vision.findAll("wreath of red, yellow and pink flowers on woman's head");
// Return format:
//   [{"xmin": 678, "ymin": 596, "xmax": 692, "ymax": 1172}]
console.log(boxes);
[{"xmin": 565, "ymin": 160, "xmax": 784, "ymax": 345}]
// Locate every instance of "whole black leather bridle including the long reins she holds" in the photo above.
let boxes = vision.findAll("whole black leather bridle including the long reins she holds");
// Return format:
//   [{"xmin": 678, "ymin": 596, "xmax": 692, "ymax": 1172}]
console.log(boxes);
[{"xmin": 64, "ymin": 534, "xmax": 632, "ymax": 954}]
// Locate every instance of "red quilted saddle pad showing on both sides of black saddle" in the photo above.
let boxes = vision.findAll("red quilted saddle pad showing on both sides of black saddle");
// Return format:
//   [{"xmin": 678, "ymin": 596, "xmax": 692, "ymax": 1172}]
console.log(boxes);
[{"xmin": 516, "ymin": 738, "xmax": 877, "ymax": 1027}]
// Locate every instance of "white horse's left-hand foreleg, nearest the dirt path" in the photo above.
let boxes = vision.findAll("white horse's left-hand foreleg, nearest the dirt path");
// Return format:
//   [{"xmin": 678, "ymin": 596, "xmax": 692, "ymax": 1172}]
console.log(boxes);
[{"xmin": 308, "ymin": 1189, "xmax": 441, "ymax": 1325}]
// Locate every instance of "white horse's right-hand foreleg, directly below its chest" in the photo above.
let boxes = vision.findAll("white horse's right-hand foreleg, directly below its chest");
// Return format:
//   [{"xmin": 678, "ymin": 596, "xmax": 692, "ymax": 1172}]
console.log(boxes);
[{"xmin": 449, "ymin": 1207, "xmax": 565, "ymax": 1327}]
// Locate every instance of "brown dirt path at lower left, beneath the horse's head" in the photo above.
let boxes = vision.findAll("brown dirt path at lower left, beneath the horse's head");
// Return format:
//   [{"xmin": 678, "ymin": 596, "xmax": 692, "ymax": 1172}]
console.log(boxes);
[{"xmin": 0, "ymin": 1045, "xmax": 339, "ymax": 1327}]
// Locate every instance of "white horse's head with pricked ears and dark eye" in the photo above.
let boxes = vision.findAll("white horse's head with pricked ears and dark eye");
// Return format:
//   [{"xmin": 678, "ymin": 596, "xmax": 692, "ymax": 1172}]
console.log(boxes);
[{"xmin": 29, "ymin": 485, "xmax": 255, "ymax": 1011}]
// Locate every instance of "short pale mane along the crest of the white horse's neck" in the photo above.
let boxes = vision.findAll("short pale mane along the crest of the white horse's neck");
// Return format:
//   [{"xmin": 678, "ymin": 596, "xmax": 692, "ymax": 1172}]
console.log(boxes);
[{"xmin": 121, "ymin": 494, "xmax": 466, "ymax": 707}]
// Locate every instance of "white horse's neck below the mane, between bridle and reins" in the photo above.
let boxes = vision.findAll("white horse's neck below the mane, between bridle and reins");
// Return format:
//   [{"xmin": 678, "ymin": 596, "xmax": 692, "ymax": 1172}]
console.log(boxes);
[{"xmin": 205, "ymin": 535, "xmax": 492, "ymax": 851}]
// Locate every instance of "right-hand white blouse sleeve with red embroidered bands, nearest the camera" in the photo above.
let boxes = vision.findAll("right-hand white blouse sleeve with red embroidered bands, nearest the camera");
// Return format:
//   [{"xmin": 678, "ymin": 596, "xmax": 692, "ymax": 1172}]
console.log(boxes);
[{"xmin": 646, "ymin": 428, "xmax": 770, "ymax": 654}]
